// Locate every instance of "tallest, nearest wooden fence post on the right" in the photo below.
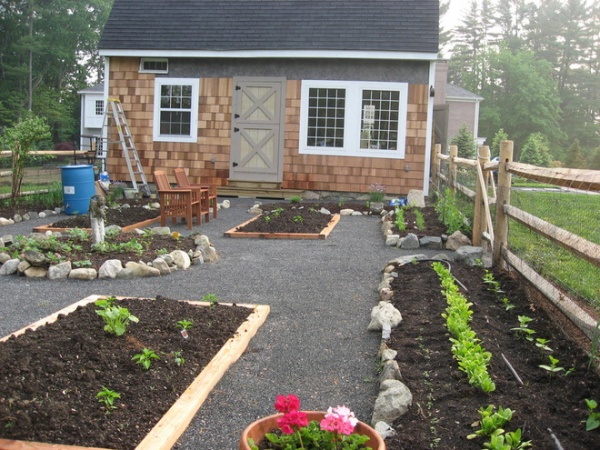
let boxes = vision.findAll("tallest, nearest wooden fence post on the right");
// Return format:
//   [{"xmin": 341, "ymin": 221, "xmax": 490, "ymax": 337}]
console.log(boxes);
[{"xmin": 492, "ymin": 141, "xmax": 513, "ymax": 269}]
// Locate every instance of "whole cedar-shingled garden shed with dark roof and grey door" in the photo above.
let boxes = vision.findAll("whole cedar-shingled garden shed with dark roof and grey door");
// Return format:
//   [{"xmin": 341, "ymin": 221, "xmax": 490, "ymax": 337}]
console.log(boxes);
[{"xmin": 99, "ymin": 0, "xmax": 439, "ymax": 194}]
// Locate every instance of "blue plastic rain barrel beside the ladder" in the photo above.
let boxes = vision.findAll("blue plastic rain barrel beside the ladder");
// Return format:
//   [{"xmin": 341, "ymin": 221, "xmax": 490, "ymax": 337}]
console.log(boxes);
[{"xmin": 60, "ymin": 165, "xmax": 96, "ymax": 214}]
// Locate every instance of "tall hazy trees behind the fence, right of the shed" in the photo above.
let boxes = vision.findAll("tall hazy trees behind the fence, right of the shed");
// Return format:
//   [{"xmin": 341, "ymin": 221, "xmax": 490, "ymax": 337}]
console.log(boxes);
[{"xmin": 440, "ymin": 0, "xmax": 600, "ymax": 170}]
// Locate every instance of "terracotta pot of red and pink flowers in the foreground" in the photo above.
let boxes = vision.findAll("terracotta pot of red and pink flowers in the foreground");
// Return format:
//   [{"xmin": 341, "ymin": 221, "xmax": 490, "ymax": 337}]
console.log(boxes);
[{"xmin": 239, "ymin": 394, "xmax": 385, "ymax": 450}]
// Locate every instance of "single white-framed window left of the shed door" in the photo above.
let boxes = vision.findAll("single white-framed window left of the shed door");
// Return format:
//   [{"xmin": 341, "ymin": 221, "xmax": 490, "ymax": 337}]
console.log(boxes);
[{"xmin": 154, "ymin": 78, "xmax": 200, "ymax": 142}]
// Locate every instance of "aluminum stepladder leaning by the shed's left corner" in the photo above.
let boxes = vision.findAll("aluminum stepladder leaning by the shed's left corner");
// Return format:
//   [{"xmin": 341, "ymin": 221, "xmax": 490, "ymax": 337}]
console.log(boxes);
[{"xmin": 104, "ymin": 97, "xmax": 150, "ymax": 196}]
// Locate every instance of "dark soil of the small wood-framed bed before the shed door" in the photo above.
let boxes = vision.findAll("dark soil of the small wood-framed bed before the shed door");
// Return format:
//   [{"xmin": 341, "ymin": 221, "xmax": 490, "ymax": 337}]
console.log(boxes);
[{"xmin": 235, "ymin": 202, "xmax": 369, "ymax": 234}]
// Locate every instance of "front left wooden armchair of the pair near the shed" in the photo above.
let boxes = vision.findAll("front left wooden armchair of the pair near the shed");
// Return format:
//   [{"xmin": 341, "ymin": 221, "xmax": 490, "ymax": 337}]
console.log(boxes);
[{"xmin": 154, "ymin": 170, "xmax": 202, "ymax": 230}]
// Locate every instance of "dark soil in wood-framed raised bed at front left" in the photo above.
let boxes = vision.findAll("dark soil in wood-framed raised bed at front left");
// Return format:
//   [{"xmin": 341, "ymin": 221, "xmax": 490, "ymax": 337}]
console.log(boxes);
[{"xmin": 0, "ymin": 298, "xmax": 251, "ymax": 449}]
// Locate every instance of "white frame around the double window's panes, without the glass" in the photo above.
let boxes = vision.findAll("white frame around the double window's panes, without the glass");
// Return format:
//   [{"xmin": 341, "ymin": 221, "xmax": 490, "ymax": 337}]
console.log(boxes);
[{"xmin": 298, "ymin": 80, "xmax": 408, "ymax": 159}]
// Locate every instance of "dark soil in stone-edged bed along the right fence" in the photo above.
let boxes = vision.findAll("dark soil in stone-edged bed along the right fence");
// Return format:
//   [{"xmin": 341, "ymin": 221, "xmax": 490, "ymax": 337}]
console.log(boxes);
[{"xmin": 386, "ymin": 263, "xmax": 600, "ymax": 450}]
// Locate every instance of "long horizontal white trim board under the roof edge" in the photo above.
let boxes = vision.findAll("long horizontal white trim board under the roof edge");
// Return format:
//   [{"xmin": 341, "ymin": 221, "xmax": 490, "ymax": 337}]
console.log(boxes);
[{"xmin": 99, "ymin": 49, "xmax": 438, "ymax": 61}]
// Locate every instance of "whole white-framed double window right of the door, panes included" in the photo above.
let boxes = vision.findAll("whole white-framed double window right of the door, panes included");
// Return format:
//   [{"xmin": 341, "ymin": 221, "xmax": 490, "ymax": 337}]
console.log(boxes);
[{"xmin": 300, "ymin": 80, "xmax": 408, "ymax": 158}]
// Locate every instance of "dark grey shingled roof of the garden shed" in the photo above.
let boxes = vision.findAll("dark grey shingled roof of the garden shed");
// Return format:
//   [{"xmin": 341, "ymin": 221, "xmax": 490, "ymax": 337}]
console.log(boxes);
[{"xmin": 99, "ymin": 0, "xmax": 439, "ymax": 54}]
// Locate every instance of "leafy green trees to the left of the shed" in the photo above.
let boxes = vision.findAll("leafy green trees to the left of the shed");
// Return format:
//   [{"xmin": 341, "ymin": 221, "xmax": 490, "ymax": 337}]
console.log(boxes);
[{"xmin": 0, "ymin": 0, "xmax": 113, "ymax": 146}]
